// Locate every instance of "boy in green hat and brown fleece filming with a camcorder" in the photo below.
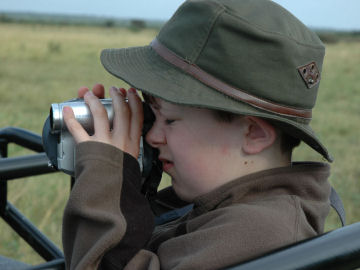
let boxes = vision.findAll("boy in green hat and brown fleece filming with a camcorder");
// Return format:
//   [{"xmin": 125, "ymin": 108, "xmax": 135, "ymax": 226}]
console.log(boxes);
[{"xmin": 63, "ymin": 0, "xmax": 331, "ymax": 269}]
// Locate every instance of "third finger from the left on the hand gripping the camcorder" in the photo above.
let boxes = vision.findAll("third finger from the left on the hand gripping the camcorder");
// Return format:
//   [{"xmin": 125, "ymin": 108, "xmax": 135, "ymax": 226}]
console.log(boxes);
[{"xmin": 110, "ymin": 87, "xmax": 130, "ymax": 142}]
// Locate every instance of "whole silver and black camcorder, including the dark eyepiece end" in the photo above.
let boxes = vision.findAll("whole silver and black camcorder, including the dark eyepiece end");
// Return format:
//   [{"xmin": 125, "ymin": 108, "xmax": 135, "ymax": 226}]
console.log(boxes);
[{"xmin": 42, "ymin": 99, "xmax": 162, "ymax": 194}]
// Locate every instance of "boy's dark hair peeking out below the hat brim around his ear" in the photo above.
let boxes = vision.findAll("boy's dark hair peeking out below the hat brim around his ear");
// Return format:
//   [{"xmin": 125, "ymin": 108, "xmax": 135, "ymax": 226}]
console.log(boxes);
[{"xmin": 212, "ymin": 110, "xmax": 301, "ymax": 154}]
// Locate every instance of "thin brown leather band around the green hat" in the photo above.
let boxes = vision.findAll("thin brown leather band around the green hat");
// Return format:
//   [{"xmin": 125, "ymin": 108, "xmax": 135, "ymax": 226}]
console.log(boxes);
[{"xmin": 150, "ymin": 38, "xmax": 312, "ymax": 120}]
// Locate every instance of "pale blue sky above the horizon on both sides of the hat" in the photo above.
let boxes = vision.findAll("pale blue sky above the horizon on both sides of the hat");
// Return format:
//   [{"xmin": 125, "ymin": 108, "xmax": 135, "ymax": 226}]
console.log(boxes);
[{"xmin": 0, "ymin": 0, "xmax": 360, "ymax": 30}]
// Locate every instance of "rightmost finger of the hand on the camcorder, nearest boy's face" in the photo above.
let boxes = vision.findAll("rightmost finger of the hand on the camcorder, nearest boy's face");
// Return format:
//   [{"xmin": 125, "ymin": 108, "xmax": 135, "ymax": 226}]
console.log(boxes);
[{"xmin": 128, "ymin": 88, "xmax": 144, "ymax": 144}]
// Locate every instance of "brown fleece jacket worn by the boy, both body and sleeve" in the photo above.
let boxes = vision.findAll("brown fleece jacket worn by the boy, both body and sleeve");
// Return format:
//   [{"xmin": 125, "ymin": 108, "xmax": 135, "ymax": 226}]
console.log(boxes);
[{"xmin": 63, "ymin": 142, "xmax": 330, "ymax": 270}]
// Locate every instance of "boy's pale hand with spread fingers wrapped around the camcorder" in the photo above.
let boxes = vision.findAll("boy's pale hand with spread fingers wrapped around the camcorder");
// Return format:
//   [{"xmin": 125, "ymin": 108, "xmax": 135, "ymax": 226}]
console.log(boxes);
[{"xmin": 63, "ymin": 84, "xmax": 144, "ymax": 158}]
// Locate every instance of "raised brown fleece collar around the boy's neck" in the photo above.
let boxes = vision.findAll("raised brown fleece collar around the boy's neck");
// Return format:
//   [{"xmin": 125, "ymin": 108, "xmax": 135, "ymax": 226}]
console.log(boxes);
[{"xmin": 191, "ymin": 162, "xmax": 330, "ymax": 216}]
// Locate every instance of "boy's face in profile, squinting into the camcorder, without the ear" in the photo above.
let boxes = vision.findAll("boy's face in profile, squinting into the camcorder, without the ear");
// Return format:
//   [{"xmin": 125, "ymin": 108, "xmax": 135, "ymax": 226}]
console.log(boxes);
[{"xmin": 146, "ymin": 98, "xmax": 248, "ymax": 201}]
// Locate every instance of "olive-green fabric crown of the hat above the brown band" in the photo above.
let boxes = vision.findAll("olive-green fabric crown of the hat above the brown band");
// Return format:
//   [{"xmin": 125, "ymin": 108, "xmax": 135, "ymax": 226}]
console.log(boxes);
[{"xmin": 157, "ymin": 0, "xmax": 325, "ymax": 109}]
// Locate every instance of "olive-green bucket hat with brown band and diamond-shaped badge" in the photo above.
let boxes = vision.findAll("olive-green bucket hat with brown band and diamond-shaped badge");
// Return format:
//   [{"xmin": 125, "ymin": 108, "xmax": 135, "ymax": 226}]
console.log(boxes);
[{"xmin": 101, "ymin": 0, "xmax": 332, "ymax": 161}]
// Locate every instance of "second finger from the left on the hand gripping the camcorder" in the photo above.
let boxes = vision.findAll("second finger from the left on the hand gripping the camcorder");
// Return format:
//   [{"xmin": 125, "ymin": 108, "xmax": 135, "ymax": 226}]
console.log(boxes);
[{"xmin": 84, "ymin": 91, "xmax": 110, "ymax": 141}]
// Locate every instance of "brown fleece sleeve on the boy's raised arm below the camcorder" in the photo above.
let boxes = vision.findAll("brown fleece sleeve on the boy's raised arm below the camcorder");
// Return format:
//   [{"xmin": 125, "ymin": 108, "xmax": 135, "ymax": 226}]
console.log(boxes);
[{"xmin": 63, "ymin": 142, "xmax": 157, "ymax": 269}]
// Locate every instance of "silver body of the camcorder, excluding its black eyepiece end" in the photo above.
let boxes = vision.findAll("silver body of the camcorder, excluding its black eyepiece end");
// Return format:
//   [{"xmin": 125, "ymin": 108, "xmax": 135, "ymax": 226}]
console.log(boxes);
[{"xmin": 43, "ymin": 99, "xmax": 143, "ymax": 176}]
